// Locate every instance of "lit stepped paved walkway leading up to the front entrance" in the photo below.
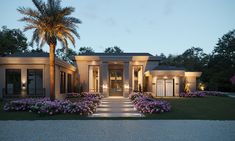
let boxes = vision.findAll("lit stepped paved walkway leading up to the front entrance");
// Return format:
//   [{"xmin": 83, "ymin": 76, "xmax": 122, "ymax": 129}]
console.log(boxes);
[{"xmin": 92, "ymin": 97, "xmax": 143, "ymax": 117}]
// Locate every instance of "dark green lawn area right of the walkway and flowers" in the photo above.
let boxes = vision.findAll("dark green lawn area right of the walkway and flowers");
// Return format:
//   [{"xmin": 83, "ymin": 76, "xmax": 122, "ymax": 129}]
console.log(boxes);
[{"xmin": 147, "ymin": 96, "xmax": 235, "ymax": 120}]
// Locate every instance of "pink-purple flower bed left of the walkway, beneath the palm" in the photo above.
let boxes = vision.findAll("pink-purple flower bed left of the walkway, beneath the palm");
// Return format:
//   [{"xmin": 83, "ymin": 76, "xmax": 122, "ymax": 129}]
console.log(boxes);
[{"xmin": 3, "ymin": 93, "xmax": 101, "ymax": 115}]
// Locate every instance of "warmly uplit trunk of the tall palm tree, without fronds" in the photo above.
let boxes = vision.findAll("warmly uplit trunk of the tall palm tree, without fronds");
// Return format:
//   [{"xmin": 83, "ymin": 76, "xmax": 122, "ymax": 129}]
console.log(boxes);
[{"xmin": 49, "ymin": 43, "xmax": 55, "ymax": 101}]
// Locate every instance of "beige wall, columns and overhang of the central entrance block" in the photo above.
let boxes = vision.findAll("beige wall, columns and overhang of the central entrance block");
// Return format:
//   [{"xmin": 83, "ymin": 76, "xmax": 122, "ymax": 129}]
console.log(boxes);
[{"xmin": 75, "ymin": 56, "xmax": 159, "ymax": 97}]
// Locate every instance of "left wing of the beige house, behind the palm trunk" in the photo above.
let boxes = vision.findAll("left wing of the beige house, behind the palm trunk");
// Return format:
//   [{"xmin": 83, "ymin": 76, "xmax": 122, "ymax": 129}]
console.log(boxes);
[{"xmin": 0, "ymin": 53, "xmax": 76, "ymax": 98}]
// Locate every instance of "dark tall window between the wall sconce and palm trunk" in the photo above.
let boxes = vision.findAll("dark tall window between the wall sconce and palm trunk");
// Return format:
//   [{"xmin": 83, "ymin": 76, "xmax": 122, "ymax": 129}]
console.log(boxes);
[{"xmin": 27, "ymin": 69, "xmax": 43, "ymax": 95}]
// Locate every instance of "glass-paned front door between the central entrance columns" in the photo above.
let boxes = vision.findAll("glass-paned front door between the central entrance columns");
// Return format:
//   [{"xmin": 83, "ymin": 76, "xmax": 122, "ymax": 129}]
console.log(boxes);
[{"xmin": 109, "ymin": 69, "xmax": 123, "ymax": 96}]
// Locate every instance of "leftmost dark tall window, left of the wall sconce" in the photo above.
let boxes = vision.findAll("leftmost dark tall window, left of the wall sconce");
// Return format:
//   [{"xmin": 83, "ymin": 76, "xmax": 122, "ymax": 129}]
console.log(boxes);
[{"xmin": 6, "ymin": 69, "xmax": 21, "ymax": 95}]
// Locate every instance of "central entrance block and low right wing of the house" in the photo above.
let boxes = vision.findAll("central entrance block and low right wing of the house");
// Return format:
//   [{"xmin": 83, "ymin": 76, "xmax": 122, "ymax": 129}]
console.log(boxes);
[{"xmin": 75, "ymin": 53, "xmax": 201, "ymax": 97}]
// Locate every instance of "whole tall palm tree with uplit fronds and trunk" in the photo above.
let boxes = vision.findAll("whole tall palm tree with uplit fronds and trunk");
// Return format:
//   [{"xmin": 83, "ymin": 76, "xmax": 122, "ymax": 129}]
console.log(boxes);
[{"xmin": 17, "ymin": 0, "xmax": 81, "ymax": 100}]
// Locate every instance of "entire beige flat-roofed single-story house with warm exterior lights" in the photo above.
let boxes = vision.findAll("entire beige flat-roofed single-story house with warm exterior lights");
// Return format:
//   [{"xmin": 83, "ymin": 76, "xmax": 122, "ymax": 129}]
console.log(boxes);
[{"xmin": 0, "ymin": 53, "xmax": 201, "ymax": 98}]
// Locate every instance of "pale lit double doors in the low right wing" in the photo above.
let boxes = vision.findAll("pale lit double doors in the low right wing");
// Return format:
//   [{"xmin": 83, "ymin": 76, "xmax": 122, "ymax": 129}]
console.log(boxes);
[{"xmin": 157, "ymin": 79, "xmax": 174, "ymax": 97}]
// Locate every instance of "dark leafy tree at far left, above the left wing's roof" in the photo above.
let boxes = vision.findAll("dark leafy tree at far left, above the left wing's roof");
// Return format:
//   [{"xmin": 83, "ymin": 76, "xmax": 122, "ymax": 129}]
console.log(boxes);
[{"xmin": 0, "ymin": 26, "xmax": 28, "ymax": 56}]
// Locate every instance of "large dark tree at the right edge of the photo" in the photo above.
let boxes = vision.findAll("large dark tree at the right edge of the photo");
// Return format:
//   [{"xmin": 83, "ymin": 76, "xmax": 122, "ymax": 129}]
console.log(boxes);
[{"xmin": 205, "ymin": 30, "xmax": 235, "ymax": 91}]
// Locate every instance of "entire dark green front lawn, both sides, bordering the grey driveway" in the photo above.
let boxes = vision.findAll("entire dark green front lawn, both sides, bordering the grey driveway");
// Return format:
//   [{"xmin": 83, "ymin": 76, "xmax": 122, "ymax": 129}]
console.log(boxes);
[{"xmin": 0, "ymin": 96, "xmax": 235, "ymax": 120}]
